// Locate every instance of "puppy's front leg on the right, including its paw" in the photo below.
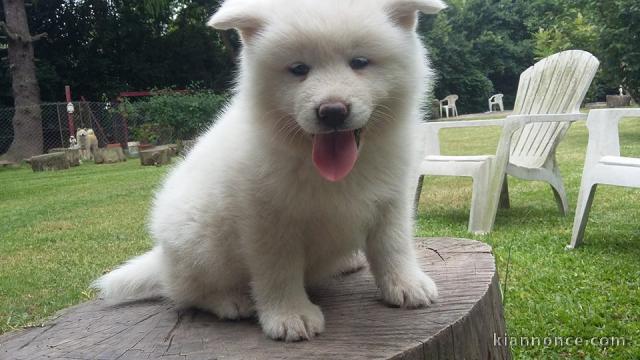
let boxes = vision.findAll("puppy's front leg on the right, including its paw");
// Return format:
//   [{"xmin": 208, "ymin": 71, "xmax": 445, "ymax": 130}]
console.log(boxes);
[{"xmin": 366, "ymin": 201, "xmax": 438, "ymax": 308}]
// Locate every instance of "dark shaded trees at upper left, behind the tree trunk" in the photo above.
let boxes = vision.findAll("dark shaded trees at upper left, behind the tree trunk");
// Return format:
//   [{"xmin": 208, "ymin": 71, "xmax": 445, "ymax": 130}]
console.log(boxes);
[{"xmin": 0, "ymin": 0, "xmax": 235, "ymax": 105}]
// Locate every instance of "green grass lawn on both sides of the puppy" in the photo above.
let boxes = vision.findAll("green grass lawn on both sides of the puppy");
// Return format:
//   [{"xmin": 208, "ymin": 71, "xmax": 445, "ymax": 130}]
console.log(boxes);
[{"xmin": 0, "ymin": 120, "xmax": 640, "ymax": 359}]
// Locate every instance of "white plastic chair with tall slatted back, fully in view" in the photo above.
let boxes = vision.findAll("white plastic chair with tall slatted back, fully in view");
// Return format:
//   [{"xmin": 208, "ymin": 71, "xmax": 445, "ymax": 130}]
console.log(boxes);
[{"xmin": 415, "ymin": 50, "xmax": 599, "ymax": 234}]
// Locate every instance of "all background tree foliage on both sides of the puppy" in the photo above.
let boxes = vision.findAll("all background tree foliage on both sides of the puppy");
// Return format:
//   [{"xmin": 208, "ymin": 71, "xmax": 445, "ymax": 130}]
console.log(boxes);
[{"xmin": 0, "ymin": 0, "xmax": 640, "ymax": 113}]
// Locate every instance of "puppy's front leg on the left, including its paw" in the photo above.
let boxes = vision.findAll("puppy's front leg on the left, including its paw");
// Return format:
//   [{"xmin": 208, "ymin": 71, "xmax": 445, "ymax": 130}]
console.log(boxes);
[{"xmin": 249, "ymin": 225, "xmax": 324, "ymax": 341}]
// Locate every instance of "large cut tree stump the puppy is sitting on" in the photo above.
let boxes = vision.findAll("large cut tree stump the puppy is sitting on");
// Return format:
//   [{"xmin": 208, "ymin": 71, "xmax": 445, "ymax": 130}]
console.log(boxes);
[{"xmin": 0, "ymin": 238, "xmax": 511, "ymax": 360}]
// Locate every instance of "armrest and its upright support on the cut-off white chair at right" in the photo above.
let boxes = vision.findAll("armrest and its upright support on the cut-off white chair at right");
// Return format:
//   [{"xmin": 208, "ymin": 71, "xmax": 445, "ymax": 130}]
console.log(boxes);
[{"xmin": 585, "ymin": 108, "xmax": 640, "ymax": 163}]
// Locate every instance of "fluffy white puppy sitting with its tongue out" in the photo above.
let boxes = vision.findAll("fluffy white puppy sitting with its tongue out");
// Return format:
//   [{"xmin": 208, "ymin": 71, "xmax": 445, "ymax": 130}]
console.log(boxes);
[{"xmin": 94, "ymin": 0, "xmax": 445, "ymax": 341}]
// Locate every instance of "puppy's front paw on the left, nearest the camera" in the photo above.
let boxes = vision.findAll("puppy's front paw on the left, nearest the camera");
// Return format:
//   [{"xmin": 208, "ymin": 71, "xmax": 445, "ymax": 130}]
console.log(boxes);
[{"xmin": 260, "ymin": 302, "xmax": 324, "ymax": 341}]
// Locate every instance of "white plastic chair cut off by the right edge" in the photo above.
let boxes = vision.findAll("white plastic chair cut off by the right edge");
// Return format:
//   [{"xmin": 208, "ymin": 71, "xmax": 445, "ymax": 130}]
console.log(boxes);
[{"xmin": 567, "ymin": 109, "xmax": 640, "ymax": 249}]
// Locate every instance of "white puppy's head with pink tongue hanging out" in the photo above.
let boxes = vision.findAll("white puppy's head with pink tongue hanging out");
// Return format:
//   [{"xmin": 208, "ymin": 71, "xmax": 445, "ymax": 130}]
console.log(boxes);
[{"xmin": 209, "ymin": 0, "xmax": 445, "ymax": 181}]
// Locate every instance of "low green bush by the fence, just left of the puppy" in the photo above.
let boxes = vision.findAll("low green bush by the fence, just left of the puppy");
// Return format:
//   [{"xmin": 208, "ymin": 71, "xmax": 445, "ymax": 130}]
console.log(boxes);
[{"xmin": 121, "ymin": 90, "xmax": 227, "ymax": 144}]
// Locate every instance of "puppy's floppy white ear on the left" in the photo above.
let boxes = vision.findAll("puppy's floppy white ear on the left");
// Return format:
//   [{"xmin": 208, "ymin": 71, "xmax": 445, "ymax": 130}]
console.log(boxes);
[{"xmin": 207, "ymin": 0, "xmax": 265, "ymax": 41}]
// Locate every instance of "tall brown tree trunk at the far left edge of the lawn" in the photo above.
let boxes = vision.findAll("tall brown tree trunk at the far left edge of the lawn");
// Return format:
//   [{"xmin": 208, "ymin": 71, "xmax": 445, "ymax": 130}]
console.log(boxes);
[{"xmin": 0, "ymin": 0, "xmax": 46, "ymax": 161}]
